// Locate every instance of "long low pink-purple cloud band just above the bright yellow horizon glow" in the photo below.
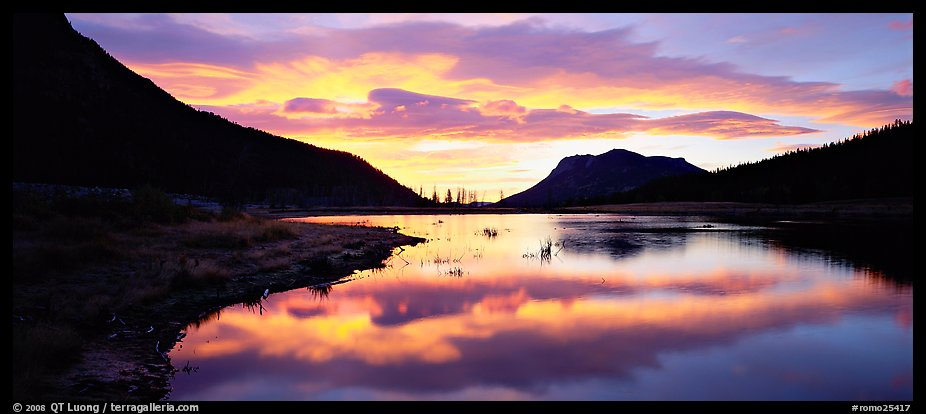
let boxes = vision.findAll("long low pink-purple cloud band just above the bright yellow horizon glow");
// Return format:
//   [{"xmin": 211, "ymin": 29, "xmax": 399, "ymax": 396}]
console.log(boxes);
[{"xmin": 201, "ymin": 88, "xmax": 818, "ymax": 142}]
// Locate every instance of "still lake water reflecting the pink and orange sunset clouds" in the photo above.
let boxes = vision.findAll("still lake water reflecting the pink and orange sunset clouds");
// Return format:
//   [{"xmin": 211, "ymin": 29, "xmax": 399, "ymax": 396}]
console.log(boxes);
[{"xmin": 170, "ymin": 214, "xmax": 913, "ymax": 400}]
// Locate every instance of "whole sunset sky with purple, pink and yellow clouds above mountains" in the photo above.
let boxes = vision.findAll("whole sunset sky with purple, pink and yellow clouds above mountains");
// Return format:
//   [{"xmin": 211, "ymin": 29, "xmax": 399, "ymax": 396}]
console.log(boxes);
[{"xmin": 67, "ymin": 13, "xmax": 913, "ymax": 201}]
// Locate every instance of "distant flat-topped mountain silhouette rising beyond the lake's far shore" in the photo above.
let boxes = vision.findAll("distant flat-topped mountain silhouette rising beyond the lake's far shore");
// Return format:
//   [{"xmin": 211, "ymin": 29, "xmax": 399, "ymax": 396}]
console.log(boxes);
[{"xmin": 497, "ymin": 149, "xmax": 705, "ymax": 207}]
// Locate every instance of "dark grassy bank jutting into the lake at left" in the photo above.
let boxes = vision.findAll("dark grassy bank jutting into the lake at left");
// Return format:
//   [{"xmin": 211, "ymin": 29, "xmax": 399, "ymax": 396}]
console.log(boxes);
[{"xmin": 13, "ymin": 189, "xmax": 420, "ymax": 400}]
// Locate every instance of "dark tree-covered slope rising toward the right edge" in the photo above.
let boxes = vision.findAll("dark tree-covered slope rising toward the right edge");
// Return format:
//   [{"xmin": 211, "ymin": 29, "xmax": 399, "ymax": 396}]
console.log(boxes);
[{"xmin": 582, "ymin": 120, "xmax": 915, "ymax": 205}]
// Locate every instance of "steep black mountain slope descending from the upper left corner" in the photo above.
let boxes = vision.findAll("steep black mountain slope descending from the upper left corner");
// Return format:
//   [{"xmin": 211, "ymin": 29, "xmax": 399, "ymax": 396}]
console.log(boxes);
[{"xmin": 12, "ymin": 14, "xmax": 424, "ymax": 205}]
